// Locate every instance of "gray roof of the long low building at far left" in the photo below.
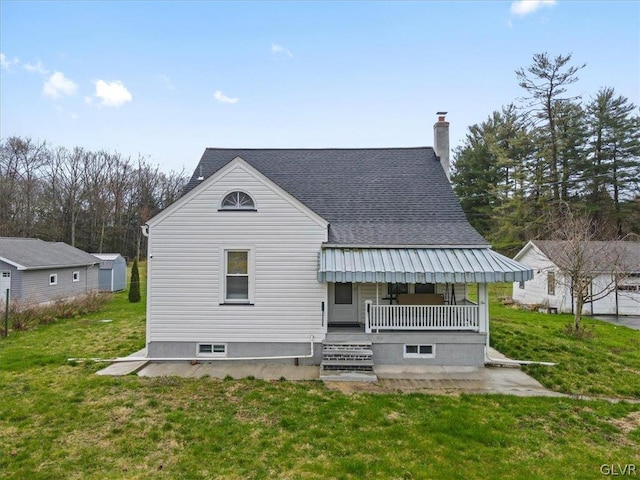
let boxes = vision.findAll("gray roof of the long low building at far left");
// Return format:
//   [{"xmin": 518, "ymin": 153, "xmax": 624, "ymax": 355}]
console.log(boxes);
[{"xmin": 0, "ymin": 237, "xmax": 100, "ymax": 270}]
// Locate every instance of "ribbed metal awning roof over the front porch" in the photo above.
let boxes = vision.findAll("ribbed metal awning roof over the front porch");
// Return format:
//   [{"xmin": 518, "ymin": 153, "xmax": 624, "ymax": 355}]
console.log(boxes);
[{"xmin": 318, "ymin": 248, "xmax": 533, "ymax": 283}]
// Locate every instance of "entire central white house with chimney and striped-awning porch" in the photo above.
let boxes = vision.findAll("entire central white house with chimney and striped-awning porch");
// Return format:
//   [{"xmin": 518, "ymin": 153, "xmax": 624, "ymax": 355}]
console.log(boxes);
[{"xmin": 145, "ymin": 116, "xmax": 532, "ymax": 371}]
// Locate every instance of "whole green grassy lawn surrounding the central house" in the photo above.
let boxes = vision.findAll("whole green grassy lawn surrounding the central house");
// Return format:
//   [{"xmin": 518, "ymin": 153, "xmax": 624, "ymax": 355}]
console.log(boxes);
[{"xmin": 0, "ymin": 272, "xmax": 640, "ymax": 479}]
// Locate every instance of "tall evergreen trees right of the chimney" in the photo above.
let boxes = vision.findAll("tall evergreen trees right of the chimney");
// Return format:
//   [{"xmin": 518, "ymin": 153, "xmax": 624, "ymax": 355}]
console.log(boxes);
[{"xmin": 452, "ymin": 53, "xmax": 640, "ymax": 254}]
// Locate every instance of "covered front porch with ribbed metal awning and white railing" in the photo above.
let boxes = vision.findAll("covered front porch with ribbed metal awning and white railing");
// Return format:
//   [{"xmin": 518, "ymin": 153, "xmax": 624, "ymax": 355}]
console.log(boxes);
[{"xmin": 318, "ymin": 248, "xmax": 533, "ymax": 341}]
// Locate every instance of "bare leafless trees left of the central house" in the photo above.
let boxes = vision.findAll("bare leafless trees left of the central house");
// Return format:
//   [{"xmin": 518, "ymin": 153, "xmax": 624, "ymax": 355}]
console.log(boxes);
[{"xmin": 0, "ymin": 136, "xmax": 187, "ymax": 258}]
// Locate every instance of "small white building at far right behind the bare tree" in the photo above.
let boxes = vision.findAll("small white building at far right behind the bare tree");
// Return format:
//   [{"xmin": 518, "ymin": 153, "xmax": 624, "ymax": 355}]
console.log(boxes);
[{"xmin": 513, "ymin": 240, "xmax": 640, "ymax": 315}]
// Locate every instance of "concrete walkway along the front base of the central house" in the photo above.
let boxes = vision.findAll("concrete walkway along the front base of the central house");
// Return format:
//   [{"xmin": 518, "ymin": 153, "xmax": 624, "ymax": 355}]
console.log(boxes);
[{"xmin": 98, "ymin": 349, "xmax": 565, "ymax": 397}]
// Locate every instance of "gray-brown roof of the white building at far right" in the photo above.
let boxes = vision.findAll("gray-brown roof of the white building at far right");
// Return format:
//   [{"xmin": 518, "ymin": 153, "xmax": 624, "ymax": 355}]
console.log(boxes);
[{"xmin": 531, "ymin": 240, "xmax": 640, "ymax": 273}]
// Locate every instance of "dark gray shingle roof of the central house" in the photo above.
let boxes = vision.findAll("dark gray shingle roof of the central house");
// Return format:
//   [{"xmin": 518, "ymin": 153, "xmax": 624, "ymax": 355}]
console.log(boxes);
[{"xmin": 185, "ymin": 147, "xmax": 487, "ymax": 246}]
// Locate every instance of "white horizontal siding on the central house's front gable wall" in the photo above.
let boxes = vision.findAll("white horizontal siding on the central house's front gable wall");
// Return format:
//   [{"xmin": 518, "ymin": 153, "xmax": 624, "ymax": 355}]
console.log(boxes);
[{"xmin": 147, "ymin": 164, "xmax": 327, "ymax": 343}]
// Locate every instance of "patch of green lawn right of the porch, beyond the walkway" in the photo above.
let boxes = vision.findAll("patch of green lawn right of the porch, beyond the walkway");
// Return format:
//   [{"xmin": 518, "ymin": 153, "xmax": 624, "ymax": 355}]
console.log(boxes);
[{"xmin": 490, "ymin": 286, "xmax": 640, "ymax": 399}]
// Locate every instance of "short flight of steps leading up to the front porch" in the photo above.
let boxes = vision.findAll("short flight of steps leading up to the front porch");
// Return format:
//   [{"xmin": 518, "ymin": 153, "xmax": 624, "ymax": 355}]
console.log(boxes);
[{"xmin": 320, "ymin": 342, "xmax": 378, "ymax": 382}]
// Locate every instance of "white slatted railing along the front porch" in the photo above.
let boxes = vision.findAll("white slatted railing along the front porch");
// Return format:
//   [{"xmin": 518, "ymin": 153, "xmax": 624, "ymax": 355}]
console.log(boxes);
[{"xmin": 365, "ymin": 300, "xmax": 480, "ymax": 333}]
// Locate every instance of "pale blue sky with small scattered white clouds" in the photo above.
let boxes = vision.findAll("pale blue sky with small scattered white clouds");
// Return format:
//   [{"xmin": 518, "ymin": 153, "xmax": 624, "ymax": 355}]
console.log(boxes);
[{"xmin": 0, "ymin": 0, "xmax": 640, "ymax": 174}]
